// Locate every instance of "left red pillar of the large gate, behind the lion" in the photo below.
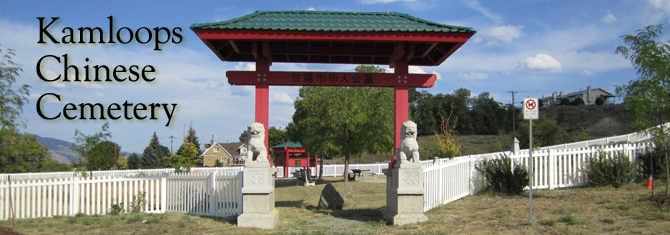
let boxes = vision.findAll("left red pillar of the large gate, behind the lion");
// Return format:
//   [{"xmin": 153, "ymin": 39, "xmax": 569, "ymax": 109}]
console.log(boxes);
[{"xmin": 256, "ymin": 57, "xmax": 272, "ymax": 166}]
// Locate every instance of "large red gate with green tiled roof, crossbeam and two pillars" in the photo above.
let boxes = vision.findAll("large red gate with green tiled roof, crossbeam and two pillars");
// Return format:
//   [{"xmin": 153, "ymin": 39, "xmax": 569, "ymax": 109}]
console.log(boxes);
[{"xmin": 191, "ymin": 11, "xmax": 476, "ymax": 168}]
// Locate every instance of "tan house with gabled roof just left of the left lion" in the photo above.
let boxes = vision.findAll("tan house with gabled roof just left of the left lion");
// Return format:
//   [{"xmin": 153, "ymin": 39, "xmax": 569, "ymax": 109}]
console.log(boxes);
[{"xmin": 200, "ymin": 141, "xmax": 247, "ymax": 167}]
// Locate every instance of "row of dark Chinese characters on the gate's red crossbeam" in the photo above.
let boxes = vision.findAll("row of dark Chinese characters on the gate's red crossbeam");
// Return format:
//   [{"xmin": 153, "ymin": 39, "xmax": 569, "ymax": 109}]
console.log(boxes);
[{"xmin": 291, "ymin": 72, "xmax": 374, "ymax": 85}]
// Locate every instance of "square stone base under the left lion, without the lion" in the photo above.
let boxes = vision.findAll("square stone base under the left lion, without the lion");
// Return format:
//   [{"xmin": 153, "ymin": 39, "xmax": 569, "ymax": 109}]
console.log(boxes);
[{"xmin": 237, "ymin": 166, "xmax": 279, "ymax": 229}]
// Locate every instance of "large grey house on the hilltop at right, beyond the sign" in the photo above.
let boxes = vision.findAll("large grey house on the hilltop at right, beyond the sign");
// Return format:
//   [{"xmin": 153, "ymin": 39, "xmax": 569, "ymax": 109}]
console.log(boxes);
[{"xmin": 540, "ymin": 86, "xmax": 615, "ymax": 107}]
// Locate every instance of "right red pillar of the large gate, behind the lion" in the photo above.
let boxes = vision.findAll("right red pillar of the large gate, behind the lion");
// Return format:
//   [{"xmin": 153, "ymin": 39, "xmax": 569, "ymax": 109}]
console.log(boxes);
[{"xmin": 389, "ymin": 60, "xmax": 409, "ymax": 168}]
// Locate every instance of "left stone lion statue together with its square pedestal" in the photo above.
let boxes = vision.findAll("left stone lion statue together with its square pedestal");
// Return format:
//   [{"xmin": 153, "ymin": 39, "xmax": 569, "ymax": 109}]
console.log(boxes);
[{"xmin": 237, "ymin": 123, "xmax": 279, "ymax": 229}]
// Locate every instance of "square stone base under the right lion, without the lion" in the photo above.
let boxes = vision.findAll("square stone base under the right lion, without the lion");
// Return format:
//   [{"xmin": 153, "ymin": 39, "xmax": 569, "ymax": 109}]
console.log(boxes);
[{"xmin": 384, "ymin": 164, "xmax": 428, "ymax": 226}]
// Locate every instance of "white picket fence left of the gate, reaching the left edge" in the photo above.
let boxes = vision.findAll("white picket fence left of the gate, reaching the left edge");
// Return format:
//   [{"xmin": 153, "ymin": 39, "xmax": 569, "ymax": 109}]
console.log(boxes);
[{"xmin": 0, "ymin": 172, "xmax": 242, "ymax": 220}]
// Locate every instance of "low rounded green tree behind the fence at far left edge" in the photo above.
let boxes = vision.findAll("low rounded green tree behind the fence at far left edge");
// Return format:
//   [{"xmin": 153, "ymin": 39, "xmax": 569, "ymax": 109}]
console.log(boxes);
[{"xmin": 0, "ymin": 127, "xmax": 49, "ymax": 173}]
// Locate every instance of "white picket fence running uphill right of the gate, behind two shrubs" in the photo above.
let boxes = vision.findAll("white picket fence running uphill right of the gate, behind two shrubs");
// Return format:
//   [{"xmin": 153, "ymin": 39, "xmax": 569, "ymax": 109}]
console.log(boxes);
[{"xmin": 422, "ymin": 143, "xmax": 652, "ymax": 211}]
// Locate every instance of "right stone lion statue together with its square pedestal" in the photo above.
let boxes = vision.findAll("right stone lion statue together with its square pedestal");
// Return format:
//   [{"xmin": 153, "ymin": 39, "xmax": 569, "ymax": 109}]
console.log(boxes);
[{"xmin": 383, "ymin": 121, "xmax": 428, "ymax": 226}]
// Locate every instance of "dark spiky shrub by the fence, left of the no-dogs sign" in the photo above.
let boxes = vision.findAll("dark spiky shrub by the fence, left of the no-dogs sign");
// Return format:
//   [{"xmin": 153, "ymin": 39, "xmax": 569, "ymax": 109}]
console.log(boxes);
[{"xmin": 476, "ymin": 154, "xmax": 528, "ymax": 195}]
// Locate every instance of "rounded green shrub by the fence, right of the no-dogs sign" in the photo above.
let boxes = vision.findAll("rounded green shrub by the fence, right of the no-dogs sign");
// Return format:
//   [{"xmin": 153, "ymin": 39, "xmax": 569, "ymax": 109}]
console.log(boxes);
[{"xmin": 586, "ymin": 152, "xmax": 633, "ymax": 188}]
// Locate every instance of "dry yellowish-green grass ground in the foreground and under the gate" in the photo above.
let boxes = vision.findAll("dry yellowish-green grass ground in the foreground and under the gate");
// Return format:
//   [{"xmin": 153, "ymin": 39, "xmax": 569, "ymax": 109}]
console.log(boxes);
[{"xmin": 0, "ymin": 177, "xmax": 670, "ymax": 234}]
